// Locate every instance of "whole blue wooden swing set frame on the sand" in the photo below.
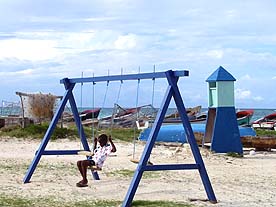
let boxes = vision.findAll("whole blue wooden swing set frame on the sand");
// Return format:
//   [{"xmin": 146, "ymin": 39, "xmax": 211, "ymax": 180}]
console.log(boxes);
[{"xmin": 23, "ymin": 70, "xmax": 217, "ymax": 207}]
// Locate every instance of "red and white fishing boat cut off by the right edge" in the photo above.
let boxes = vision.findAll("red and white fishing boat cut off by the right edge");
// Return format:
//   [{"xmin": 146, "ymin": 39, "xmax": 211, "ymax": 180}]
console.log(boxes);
[{"xmin": 252, "ymin": 113, "xmax": 276, "ymax": 131}]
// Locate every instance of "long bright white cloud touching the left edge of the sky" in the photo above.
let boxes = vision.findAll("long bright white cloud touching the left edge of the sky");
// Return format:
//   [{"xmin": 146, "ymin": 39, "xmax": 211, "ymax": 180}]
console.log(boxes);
[{"xmin": 0, "ymin": 39, "xmax": 59, "ymax": 61}]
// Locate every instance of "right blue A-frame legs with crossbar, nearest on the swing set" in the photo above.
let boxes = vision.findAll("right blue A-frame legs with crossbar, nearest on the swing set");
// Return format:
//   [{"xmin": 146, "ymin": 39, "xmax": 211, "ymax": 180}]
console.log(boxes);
[{"xmin": 122, "ymin": 71, "xmax": 217, "ymax": 207}]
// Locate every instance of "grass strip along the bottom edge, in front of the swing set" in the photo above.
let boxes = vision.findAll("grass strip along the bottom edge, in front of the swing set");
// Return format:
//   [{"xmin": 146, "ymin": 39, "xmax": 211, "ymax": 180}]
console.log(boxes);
[{"xmin": 0, "ymin": 194, "xmax": 193, "ymax": 207}]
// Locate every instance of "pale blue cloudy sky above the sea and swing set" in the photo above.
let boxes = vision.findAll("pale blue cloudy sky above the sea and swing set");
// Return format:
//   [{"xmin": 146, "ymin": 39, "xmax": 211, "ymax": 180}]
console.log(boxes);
[{"xmin": 0, "ymin": 0, "xmax": 276, "ymax": 109}]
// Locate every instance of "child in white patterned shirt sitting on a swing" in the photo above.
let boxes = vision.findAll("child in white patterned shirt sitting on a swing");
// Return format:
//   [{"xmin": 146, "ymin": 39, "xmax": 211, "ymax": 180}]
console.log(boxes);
[{"xmin": 76, "ymin": 134, "xmax": 116, "ymax": 187}]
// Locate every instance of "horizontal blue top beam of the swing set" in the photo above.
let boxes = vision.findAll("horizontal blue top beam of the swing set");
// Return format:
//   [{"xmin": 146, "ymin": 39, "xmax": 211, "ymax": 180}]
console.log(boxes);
[{"xmin": 60, "ymin": 70, "xmax": 189, "ymax": 84}]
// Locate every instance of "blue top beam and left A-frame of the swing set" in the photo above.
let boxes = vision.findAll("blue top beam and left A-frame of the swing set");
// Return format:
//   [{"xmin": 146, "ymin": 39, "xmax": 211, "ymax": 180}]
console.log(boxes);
[{"xmin": 23, "ymin": 70, "xmax": 189, "ymax": 183}]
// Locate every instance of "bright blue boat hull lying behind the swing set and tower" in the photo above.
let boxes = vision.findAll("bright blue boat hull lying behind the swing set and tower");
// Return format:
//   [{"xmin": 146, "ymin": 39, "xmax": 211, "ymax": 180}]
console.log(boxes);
[{"xmin": 139, "ymin": 124, "xmax": 256, "ymax": 143}]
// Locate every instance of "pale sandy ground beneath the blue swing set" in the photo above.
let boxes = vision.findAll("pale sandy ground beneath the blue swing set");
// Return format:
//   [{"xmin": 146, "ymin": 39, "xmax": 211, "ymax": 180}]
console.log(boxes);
[{"xmin": 0, "ymin": 138, "xmax": 276, "ymax": 207}]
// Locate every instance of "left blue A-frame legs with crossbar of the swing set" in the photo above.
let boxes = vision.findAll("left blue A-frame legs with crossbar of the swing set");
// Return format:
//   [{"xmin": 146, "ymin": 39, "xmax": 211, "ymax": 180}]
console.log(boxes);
[{"xmin": 23, "ymin": 79, "xmax": 99, "ymax": 183}]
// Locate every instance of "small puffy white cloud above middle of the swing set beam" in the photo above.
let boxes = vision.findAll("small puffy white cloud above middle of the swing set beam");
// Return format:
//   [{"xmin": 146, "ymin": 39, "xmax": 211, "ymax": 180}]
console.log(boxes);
[{"xmin": 114, "ymin": 34, "xmax": 137, "ymax": 50}]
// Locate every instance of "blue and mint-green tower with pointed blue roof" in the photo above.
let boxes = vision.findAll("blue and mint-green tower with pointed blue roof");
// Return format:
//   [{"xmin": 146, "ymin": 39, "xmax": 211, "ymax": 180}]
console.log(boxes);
[{"xmin": 204, "ymin": 66, "xmax": 243, "ymax": 154}]
